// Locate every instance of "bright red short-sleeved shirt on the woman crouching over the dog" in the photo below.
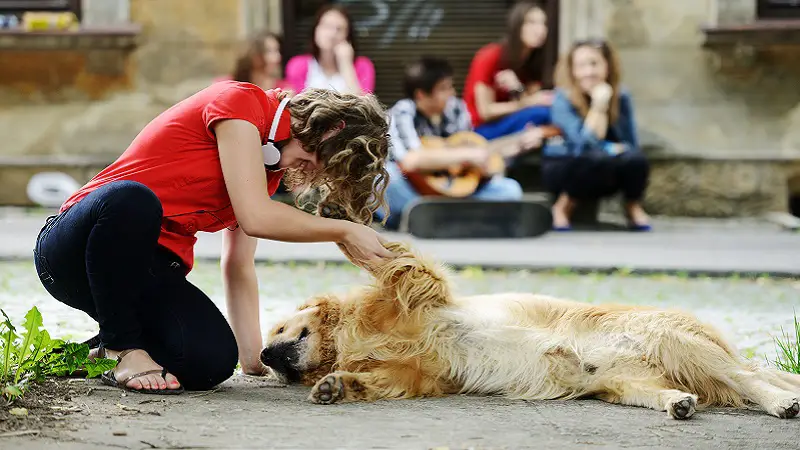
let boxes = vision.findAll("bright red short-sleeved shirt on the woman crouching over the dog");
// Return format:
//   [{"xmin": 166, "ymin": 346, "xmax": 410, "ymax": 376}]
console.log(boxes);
[{"xmin": 61, "ymin": 81, "xmax": 291, "ymax": 271}]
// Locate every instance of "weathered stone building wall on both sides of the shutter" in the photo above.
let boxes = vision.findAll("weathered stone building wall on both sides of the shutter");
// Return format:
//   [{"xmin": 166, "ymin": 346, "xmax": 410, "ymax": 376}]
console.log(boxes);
[{"xmin": 0, "ymin": 0, "xmax": 800, "ymax": 216}]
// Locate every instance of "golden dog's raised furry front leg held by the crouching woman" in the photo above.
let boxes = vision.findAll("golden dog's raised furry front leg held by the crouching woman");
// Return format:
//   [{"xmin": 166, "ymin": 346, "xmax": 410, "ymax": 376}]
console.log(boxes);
[{"xmin": 372, "ymin": 242, "xmax": 451, "ymax": 314}]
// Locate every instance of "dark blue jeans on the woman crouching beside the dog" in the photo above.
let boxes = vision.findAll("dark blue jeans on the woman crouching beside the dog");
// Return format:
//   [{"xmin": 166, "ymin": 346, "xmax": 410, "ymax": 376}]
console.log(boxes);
[{"xmin": 34, "ymin": 181, "xmax": 238, "ymax": 390}]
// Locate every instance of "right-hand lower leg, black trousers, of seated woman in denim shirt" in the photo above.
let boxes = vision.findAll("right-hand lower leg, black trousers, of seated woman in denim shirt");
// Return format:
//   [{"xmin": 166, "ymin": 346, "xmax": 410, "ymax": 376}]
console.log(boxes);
[{"xmin": 615, "ymin": 152, "xmax": 650, "ymax": 231}]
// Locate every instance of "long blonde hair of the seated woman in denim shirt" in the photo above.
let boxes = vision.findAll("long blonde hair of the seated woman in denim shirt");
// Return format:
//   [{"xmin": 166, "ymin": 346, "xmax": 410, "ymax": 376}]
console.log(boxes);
[{"xmin": 556, "ymin": 39, "xmax": 622, "ymax": 123}]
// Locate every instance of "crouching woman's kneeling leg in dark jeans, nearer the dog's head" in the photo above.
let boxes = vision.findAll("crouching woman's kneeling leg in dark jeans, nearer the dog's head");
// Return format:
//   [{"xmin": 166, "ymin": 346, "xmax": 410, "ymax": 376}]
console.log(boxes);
[{"xmin": 137, "ymin": 255, "xmax": 239, "ymax": 390}]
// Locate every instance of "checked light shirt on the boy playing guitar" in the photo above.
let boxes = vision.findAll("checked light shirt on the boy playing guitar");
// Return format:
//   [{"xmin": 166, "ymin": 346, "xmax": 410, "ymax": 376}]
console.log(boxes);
[{"xmin": 389, "ymin": 97, "xmax": 472, "ymax": 161}]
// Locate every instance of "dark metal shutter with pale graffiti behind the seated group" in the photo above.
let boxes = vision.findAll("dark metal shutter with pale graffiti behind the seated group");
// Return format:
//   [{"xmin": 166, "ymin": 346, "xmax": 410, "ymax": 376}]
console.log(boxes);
[{"xmin": 284, "ymin": 0, "xmax": 558, "ymax": 106}]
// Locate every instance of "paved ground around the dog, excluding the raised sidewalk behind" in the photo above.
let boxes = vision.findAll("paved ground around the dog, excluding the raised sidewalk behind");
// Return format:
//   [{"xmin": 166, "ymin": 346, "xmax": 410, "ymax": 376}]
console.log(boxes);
[{"xmin": 0, "ymin": 261, "xmax": 800, "ymax": 449}]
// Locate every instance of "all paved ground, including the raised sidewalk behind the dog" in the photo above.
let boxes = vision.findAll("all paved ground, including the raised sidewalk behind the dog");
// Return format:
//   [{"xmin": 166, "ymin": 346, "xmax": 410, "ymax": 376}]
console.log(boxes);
[{"xmin": 0, "ymin": 207, "xmax": 800, "ymax": 449}]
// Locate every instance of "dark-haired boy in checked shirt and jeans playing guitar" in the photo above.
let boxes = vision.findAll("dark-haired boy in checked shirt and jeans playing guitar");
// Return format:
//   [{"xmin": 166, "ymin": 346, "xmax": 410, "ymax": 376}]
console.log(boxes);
[{"xmin": 376, "ymin": 58, "xmax": 529, "ymax": 229}]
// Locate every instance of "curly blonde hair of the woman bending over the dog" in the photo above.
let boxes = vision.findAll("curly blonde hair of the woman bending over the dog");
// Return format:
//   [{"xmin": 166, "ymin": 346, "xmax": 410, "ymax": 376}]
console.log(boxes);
[{"xmin": 284, "ymin": 88, "xmax": 389, "ymax": 225}]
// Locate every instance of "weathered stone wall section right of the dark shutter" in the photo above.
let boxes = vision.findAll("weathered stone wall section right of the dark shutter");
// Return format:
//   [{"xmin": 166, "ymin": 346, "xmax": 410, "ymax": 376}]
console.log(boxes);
[{"xmin": 561, "ymin": 0, "xmax": 800, "ymax": 217}]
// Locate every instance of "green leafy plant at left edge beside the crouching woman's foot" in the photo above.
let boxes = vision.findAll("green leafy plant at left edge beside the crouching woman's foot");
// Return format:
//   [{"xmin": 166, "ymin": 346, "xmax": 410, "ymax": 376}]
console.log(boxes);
[{"xmin": 0, "ymin": 306, "xmax": 116, "ymax": 404}]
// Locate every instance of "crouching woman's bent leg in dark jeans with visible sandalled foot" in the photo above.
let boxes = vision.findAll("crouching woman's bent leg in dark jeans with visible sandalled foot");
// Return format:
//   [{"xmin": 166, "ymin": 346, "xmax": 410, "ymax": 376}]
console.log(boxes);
[{"xmin": 36, "ymin": 181, "xmax": 178, "ymax": 389}]
